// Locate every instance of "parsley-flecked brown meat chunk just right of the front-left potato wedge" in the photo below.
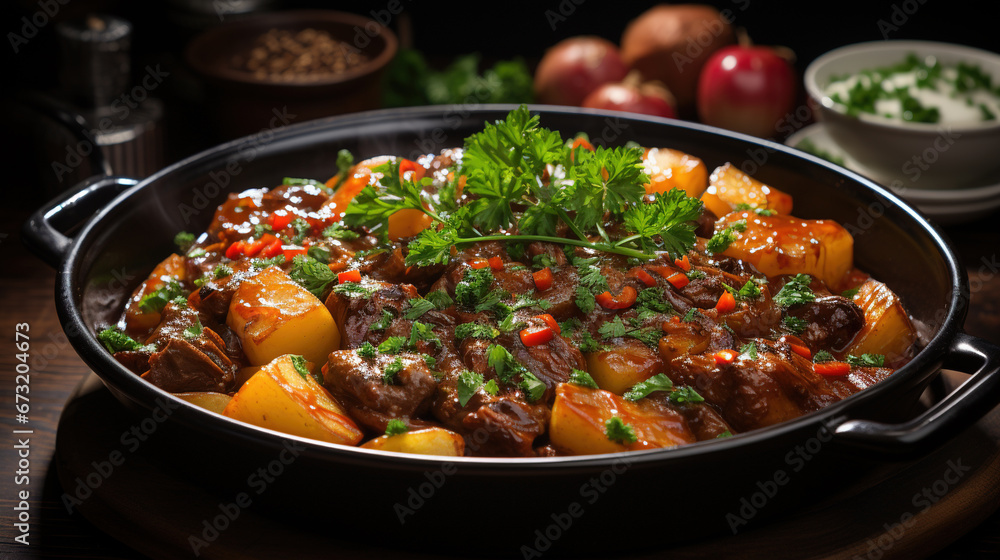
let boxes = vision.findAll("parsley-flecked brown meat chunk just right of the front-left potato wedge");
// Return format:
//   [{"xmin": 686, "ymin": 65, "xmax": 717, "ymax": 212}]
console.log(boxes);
[{"xmin": 323, "ymin": 350, "xmax": 438, "ymax": 434}]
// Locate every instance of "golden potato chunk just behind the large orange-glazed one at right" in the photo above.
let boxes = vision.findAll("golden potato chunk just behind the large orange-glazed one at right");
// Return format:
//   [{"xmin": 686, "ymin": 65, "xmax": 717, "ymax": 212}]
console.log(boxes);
[{"xmin": 701, "ymin": 163, "xmax": 792, "ymax": 218}]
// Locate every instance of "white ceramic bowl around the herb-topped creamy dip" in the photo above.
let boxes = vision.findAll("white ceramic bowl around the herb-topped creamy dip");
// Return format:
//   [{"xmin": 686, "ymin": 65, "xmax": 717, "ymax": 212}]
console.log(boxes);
[{"xmin": 805, "ymin": 41, "xmax": 1000, "ymax": 189}]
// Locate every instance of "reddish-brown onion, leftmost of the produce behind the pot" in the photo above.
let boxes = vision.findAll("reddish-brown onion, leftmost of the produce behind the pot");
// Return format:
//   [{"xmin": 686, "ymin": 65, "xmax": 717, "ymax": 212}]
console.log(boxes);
[{"xmin": 535, "ymin": 36, "xmax": 628, "ymax": 106}]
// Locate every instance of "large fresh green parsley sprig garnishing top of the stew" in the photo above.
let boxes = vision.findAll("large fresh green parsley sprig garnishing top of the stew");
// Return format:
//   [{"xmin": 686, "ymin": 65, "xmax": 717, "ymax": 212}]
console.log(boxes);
[{"xmin": 344, "ymin": 105, "xmax": 702, "ymax": 272}]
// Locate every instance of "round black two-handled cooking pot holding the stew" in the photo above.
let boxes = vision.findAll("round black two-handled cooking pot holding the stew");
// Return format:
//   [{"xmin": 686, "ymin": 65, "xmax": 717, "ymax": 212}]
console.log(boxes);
[{"xmin": 25, "ymin": 106, "xmax": 1000, "ymax": 558}]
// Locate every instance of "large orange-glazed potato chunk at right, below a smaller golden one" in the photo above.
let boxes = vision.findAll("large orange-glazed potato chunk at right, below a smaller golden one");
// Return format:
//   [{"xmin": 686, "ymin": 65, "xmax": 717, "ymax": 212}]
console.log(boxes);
[{"xmin": 715, "ymin": 212, "xmax": 854, "ymax": 291}]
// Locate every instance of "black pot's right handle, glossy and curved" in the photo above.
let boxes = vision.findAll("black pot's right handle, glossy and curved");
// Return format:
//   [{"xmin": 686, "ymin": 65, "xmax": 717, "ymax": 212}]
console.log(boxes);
[{"xmin": 828, "ymin": 333, "xmax": 1000, "ymax": 456}]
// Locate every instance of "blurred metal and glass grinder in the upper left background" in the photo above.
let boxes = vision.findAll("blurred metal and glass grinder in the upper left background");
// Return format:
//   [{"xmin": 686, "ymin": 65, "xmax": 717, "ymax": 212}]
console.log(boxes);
[{"xmin": 56, "ymin": 15, "xmax": 169, "ymax": 178}]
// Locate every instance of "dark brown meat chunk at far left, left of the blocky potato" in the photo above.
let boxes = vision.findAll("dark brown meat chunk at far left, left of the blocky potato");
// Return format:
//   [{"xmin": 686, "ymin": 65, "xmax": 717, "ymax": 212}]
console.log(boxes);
[{"xmin": 142, "ymin": 327, "xmax": 239, "ymax": 393}]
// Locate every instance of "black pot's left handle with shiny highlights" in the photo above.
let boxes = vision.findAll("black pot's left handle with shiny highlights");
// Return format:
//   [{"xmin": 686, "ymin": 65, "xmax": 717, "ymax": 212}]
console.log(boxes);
[{"xmin": 21, "ymin": 175, "xmax": 138, "ymax": 268}]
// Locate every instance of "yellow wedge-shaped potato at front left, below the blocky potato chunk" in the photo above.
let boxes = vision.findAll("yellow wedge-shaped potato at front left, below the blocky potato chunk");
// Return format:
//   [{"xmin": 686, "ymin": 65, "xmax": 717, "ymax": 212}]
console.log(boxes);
[{"xmin": 222, "ymin": 355, "xmax": 362, "ymax": 445}]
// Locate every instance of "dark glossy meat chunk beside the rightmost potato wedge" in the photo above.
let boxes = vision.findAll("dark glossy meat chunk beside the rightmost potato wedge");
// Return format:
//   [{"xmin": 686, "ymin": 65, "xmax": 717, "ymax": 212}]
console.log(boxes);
[{"xmin": 788, "ymin": 295, "xmax": 865, "ymax": 352}]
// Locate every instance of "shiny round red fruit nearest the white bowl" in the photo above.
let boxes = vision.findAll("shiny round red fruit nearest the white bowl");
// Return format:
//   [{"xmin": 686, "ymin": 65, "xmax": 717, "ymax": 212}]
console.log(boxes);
[{"xmin": 698, "ymin": 45, "xmax": 798, "ymax": 138}]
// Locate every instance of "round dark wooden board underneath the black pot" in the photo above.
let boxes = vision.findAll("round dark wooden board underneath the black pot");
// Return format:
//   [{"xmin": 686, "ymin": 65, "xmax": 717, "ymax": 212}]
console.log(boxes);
[{"xmin": 55, "ymin": 372, "xmax": 1000, "ymax": 560}]
